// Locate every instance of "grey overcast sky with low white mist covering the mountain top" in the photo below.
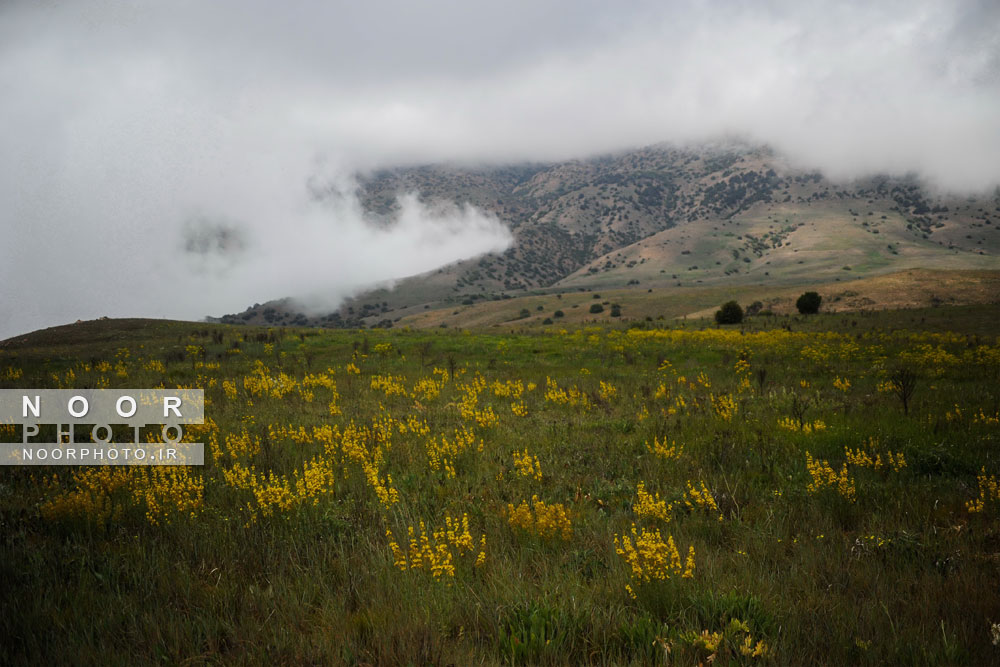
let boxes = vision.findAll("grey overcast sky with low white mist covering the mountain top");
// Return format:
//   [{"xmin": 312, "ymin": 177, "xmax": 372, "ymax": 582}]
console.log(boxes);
[{"xmin": 0, "ymin": 0, "xmax": 1000, "ymax": 338}]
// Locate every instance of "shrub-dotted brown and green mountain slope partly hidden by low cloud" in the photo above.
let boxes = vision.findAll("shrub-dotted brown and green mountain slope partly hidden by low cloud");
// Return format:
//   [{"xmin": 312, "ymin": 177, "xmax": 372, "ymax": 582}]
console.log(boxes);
[{"xmin": 221, "ymin": 144, "xmax": 1000, "ymax": 327}]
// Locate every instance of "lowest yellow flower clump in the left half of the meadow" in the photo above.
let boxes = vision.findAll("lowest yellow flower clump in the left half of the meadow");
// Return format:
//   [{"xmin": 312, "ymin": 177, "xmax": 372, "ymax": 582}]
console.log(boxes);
[{"xmin": 385, "ymin": 514, "xmax": 486, "ymax": 579}]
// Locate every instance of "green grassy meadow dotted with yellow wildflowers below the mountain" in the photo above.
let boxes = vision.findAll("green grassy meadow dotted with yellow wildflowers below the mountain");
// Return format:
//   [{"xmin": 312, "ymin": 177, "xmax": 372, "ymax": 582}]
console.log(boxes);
[{"xmin": 0, "ymin": 305, "xmax": 1000, "ymax": 665}]
